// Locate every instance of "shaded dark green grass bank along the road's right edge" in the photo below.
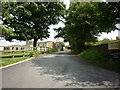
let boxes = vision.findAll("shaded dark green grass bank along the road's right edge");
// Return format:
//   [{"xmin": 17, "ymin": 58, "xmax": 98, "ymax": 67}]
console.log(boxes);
[{"xmin": 80, "ymin": 49, "xmax": 120, "ymax": 72}]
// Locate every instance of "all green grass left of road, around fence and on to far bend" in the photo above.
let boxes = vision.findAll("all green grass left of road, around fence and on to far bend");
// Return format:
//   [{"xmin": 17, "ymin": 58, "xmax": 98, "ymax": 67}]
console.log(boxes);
[{"xmin": 0, "ymin": 49, "xmax": 57, "ymax": 66}]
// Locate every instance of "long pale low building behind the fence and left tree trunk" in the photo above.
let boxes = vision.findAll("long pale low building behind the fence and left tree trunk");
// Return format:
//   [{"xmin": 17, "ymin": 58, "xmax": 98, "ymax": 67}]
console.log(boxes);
[{"xmin": 0, "ymin": 40, "xmax": 63, "ymax": 51}]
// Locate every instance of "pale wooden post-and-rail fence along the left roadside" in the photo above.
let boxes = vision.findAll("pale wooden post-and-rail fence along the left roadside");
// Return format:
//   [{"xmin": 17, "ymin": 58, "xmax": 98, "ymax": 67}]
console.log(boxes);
[{"xmin": 0, "ymin": 46, "xmax": 49, "ymax": 60}]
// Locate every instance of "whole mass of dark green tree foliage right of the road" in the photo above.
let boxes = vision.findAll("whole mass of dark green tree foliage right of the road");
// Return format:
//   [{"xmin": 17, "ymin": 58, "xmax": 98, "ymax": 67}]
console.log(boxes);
[{"xmin": 56, "ymin": 2, "xmax": 120, "ymax": 52}]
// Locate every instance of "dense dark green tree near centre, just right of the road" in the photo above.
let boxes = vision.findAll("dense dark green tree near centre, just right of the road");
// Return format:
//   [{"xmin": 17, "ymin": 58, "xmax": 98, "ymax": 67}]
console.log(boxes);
[{"xmin": 54, "ymin": 3, "xmax": 96, "ymax": 52}]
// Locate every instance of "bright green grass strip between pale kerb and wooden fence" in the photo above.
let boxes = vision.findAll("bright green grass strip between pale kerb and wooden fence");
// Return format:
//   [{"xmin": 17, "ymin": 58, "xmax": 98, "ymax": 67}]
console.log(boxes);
[{"xmin": 0, "ymin": 57, "xmax": 30, "ymax": 66}]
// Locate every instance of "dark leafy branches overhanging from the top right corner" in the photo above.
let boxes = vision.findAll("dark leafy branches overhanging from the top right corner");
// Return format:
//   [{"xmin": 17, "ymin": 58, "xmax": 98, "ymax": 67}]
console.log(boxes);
[{"xmin": 92, "ymin": 2, "xmax": 120, "ymax": 33}]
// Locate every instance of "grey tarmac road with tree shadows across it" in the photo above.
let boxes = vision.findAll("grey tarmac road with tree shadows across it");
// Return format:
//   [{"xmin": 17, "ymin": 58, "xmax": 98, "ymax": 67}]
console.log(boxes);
[{"xmin": 2, "ymin": 51, "xmax": 118, "ymax": 88}]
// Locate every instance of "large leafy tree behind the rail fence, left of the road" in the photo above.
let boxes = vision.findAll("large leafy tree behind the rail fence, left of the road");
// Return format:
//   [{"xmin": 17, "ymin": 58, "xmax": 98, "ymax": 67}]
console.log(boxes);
[{"xmin": 2, "ymin": 2, "xmax": 65, "ymax": 47}]
